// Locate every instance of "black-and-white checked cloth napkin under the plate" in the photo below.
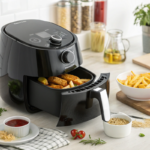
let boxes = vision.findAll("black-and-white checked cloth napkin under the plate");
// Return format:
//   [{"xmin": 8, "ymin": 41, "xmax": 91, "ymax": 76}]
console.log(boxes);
[{"xmin": 0, "ymin": 128, "xmax": 70, "ymax": 150}]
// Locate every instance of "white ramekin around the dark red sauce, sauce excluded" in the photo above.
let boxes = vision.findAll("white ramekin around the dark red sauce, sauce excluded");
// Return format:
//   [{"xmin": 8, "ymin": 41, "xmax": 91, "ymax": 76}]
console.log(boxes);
[{"xmin": 3, "ymin": 116, "xmax": 30, "ymax": 138}]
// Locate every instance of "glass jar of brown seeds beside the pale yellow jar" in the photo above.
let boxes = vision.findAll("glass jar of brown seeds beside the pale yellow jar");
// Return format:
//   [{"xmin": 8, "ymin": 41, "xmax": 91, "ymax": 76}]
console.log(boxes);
[{"xmin": 71, "ymin": 0, "xmax": 82, "ymax": 34}]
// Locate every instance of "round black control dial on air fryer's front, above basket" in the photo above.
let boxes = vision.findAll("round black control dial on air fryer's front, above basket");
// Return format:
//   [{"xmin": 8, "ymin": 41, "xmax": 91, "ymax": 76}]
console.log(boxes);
[{"xmin": 61, "ymin": 50, "xmax": 75, "ymax": 63}]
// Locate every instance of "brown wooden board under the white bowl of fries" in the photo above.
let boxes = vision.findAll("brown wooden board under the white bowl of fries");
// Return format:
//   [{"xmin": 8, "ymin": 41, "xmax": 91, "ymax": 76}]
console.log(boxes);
[{"xmin": 116, "ymin": 91, "xmax": 150, "ymax": 116}]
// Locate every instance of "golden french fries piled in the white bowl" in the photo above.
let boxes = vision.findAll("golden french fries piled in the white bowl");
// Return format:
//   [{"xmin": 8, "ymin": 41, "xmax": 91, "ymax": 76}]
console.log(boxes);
[{"xmin": 117, "ymin": 71, "xmax": 150, "ymax": 89}]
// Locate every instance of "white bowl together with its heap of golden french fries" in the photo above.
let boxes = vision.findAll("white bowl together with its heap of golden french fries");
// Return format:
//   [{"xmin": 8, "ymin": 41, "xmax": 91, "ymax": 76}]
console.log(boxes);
[{"xmin": 116, "ymin": 71, "xmax": 150, "ymax": 101}]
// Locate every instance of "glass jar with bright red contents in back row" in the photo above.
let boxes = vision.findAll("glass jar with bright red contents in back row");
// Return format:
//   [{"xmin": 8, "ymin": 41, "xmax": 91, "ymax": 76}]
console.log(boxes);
[{"xmin": 94, "ymin": 0, "xmax": 107, "ymax": 25}]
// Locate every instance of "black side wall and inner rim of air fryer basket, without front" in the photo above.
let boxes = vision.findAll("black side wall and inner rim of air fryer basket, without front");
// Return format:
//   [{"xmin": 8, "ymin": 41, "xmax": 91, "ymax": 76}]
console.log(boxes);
[{"xmin": 24, "ymin": 67, "xmax": 96, "ymax": 117}]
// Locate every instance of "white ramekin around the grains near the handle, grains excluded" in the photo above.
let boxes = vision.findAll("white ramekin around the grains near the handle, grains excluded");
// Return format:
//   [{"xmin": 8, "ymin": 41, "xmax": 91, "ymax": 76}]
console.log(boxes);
[{"xmin": 103, "ymin": 112, "xmax": 132, "ymax": 138}]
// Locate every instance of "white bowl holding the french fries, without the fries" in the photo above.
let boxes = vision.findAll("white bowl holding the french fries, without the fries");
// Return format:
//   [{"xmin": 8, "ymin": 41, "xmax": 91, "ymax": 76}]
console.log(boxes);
[{"xmin": 116, "ymin": 71, "xmax": 150, "ymax": 101}]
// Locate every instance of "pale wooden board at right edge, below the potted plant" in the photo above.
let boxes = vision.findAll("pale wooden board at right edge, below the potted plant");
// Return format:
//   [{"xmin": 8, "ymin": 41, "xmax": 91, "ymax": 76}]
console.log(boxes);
[{"xmin": 132, "ymin": 54, "xmax": 150, "ymax": 69}]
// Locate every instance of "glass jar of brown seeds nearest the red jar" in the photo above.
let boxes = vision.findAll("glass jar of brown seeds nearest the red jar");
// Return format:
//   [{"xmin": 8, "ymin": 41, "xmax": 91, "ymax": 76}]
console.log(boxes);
[{"xmin": 82, "ymin": 0, "xmax": 93, "ymax": 31}]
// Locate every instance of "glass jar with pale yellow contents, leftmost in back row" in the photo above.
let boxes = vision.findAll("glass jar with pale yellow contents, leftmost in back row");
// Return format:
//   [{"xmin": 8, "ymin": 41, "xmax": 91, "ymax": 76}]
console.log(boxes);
[{"xmin": 57, "ymin": 1, "xmax": 71, "ymax": 31}]
